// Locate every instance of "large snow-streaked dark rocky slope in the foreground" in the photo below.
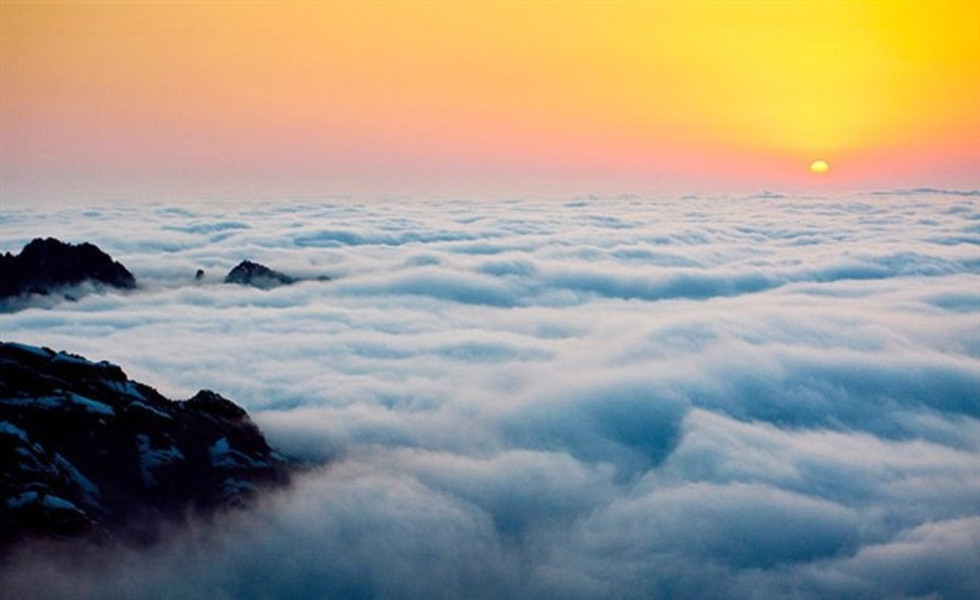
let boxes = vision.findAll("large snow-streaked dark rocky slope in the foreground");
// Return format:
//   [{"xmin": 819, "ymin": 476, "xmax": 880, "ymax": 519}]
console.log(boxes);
[{"xmin": 0, "ymin": 343, "xmax": 289, "ymax": 549}]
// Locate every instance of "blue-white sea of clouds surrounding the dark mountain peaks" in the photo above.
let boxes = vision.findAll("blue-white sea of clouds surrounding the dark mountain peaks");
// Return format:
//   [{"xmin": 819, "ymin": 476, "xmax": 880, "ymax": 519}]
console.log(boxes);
[{"xmin": 0, "ymin": 190, "xmax": 980, "ymax": 599}]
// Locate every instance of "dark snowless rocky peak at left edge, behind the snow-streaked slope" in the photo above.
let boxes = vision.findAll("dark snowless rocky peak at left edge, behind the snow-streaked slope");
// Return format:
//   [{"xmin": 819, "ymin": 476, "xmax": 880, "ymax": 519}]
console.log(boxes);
[{"xmin": 0, "ymin": 238, "xmax": 136, "ymax": 298}]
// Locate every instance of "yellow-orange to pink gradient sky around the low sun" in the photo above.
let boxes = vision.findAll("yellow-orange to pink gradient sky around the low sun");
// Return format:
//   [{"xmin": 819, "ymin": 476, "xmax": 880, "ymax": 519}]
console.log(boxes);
[{"xmin": 0, "ymin": 0, "xmax": 980, "ymax": 202}]
